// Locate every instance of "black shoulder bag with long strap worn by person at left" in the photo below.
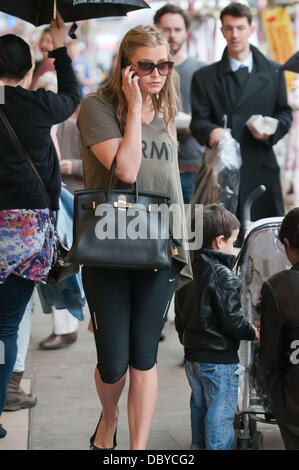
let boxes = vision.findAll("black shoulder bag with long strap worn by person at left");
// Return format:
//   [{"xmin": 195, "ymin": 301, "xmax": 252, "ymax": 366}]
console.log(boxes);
[{"xmin": 0, "ymin": 109, "xmax": 79, "ymax": 286}]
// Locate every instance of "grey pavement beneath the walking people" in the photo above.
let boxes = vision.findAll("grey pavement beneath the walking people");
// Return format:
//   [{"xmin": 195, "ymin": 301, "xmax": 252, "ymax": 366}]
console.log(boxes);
[{"xmin": 0, "ymin": 299, "xmax": 283, "ymax": 450}]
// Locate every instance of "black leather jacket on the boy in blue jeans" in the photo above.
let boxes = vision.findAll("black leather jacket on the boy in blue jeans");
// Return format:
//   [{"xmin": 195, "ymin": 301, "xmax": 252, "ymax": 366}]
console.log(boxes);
[{"xmin": 175, "ymin": 248, "xmax": 255, "ymax": 364}]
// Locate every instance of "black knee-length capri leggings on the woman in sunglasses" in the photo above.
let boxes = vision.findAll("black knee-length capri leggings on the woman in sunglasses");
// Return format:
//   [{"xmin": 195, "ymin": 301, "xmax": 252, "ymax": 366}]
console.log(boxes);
[{"xmin": 82, "ymin": 261, "xmax": 180, "ymax": 384}]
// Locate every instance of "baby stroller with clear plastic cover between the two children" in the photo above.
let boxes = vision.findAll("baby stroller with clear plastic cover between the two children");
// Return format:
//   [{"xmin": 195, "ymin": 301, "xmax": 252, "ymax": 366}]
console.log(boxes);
[{"xmin": 232, "ymin": 186, "xmax": 290, "ymax": 450}]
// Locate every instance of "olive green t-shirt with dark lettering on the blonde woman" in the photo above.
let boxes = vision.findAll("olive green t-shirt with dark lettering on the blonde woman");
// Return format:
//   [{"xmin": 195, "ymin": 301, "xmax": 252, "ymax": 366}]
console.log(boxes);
[{"xmin": 77, "ymin": 93, "xmax": 192, "ymax": 283}]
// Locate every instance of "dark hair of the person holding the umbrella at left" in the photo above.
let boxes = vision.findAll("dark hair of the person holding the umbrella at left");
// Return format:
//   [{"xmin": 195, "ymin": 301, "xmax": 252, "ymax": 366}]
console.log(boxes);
[{"xmin": 0, "ymin": 34, "xmax": 32, "ymax": 80}]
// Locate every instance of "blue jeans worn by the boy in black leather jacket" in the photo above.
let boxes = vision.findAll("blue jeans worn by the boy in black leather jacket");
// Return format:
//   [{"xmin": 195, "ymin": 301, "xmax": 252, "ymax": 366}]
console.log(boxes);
[{"xmin": 186, "ymin": 361, "xmax": 239, "ymax": 450}]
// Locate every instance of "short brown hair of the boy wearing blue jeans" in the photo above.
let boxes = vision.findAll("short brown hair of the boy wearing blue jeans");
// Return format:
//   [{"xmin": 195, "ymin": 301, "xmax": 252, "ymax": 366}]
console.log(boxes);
[{"xmin": 202, "ymin": 204, "xmax": 240, "ymax": 248}]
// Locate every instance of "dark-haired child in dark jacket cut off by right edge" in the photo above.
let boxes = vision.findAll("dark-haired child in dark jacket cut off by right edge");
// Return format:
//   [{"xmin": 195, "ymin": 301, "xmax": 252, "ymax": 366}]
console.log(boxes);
[{"xmin": 259, "ymin": 207, "xmax": 299, "ymax": 450}]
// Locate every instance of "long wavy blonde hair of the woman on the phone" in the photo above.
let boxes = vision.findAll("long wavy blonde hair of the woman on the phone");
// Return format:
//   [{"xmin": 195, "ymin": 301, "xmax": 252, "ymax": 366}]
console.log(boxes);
[{"xmin": 98, "ymin": 25, "xmax": 179, "ymax": 143}]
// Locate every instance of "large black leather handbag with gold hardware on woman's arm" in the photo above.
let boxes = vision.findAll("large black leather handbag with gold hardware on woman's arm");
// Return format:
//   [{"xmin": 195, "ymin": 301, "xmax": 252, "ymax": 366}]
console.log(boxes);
[{"xmin": 68, "ymin": 158, "xmax": 172, "ymax": 270}]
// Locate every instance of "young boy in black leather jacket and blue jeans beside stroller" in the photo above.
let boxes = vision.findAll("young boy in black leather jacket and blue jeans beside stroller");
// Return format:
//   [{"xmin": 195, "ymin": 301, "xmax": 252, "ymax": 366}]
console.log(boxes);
[{"xmin": 175, "ymin": 204, "xmax": 258, "ymax": 450}]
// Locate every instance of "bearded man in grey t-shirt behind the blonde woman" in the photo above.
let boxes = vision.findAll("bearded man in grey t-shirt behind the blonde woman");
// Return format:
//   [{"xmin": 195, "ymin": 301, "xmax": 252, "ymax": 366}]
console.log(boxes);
[{"xmin": 154, "ymin": 3, "xmax": 205, "ymax": 204}]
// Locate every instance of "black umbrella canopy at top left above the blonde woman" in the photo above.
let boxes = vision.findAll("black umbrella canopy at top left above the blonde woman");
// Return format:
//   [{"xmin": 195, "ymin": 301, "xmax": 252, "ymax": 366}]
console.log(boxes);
[{"xmin": 0, "ymin": 0, "xmax": 150, "ymax": 26}]
